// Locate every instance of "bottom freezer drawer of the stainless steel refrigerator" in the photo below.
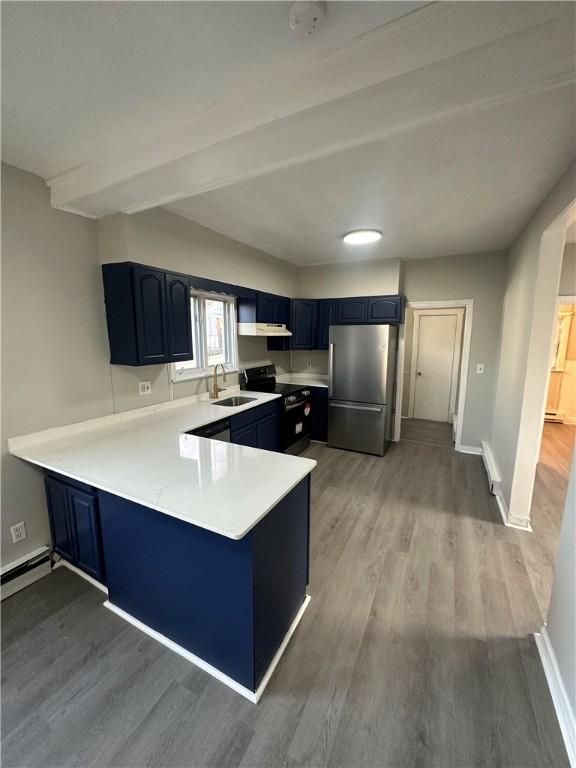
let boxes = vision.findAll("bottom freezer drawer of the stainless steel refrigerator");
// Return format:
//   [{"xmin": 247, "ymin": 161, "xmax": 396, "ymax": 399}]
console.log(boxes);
[{"xmin": 328, "ymin": 400, "xmax": 387, "ymax": 456}]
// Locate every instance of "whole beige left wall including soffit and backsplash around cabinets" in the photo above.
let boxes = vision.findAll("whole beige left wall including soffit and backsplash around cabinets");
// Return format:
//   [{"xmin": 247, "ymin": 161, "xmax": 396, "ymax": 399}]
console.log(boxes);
[{"xmin": 1, "ymin": 165, "xmax": 297, "ymax": 562}]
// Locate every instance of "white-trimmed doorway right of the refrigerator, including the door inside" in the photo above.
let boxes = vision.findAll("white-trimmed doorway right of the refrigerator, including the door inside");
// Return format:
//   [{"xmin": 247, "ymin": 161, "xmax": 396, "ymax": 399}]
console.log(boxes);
[{"xmin": 395, "ymin": 300, "xmax": 472, "ymax": 450}]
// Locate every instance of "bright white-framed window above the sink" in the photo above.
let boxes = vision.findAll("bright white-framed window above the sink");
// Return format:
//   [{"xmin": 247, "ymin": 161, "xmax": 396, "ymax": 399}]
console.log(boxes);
[{"xmin": 172, "ymin": 293, "xmax": 238, "ymax": 381}]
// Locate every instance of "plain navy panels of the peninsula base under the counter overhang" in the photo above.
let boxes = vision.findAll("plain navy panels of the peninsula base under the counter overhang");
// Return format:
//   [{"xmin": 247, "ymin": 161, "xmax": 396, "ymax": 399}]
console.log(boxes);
[{"xmin": 100, "ymin": 478, "xmax": 309, "ymax": 691}]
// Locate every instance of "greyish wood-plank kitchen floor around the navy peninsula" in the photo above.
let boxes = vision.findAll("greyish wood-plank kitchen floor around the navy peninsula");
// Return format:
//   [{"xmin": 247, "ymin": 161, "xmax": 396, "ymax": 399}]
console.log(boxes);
[{"xmin": 2, "ymin": 442, "xmax": 568, "ymax": 768}]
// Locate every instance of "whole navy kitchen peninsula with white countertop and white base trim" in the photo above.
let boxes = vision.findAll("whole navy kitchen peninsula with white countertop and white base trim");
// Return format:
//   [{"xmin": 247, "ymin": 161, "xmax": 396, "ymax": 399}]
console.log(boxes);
[{"xmin": 9, "ymin": 393, "xmax": 316, "ymax": 701}]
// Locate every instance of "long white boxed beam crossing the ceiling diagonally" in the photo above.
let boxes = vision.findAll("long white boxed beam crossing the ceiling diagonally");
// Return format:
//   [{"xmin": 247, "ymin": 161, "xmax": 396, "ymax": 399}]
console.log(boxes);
[{"xmin": 47, "ymin": 3, "xmax": 573, "ymax": 218}]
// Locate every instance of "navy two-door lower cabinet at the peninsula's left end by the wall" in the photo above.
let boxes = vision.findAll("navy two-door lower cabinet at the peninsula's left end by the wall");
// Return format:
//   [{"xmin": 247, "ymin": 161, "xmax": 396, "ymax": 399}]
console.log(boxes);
[{"xmin": 45, "ymin": 476, "xmax": 106, "ymax": 584}]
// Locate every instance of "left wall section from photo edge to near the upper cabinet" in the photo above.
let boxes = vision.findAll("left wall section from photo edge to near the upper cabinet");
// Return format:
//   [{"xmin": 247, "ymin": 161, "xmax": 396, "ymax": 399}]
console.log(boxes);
[{"xmin": 2, "ymin": 165, "xmax": 112, "ymax": 562}]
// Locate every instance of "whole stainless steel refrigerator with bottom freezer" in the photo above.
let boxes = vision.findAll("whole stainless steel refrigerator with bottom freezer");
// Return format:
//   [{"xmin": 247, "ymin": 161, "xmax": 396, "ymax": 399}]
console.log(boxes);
[{"xmin": 328, "ymin": 325, "xmax": 398, "ymax": 456}]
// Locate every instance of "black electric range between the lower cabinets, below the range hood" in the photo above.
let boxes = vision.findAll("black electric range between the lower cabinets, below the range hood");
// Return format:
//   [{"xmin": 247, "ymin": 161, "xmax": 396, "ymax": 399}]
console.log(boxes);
[{"xmin": 240, "ymin": 365, "xmax": 312, "ymax": 454}]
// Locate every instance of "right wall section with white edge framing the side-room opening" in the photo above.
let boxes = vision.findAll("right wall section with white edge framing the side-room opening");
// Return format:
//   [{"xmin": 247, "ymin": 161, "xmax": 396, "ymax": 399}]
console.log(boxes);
[{"xmin": 490, "ymin": 159, "xmax": 576, "ymax": 527}]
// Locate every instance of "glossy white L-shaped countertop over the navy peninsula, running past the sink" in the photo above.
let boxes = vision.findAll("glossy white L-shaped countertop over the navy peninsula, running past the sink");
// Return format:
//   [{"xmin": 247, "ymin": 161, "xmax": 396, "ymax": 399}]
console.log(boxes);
[{"xmin": 8, "ymin": 390, "xmax": 316, "ymax": 539}]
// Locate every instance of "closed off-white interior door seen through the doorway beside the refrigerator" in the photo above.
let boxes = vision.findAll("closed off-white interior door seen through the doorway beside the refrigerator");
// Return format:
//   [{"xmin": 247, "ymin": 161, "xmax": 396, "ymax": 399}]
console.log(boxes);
[{"xmin": 410, "ymin": 311, "xmax": 462, "ymax": 422}]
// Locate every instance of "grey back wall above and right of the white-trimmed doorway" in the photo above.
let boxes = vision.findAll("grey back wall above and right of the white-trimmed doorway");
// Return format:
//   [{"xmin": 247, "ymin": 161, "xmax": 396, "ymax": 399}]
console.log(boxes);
[{"xmin": 402, "ymin": 253, "xmax": 506, "ymax": 448}]
